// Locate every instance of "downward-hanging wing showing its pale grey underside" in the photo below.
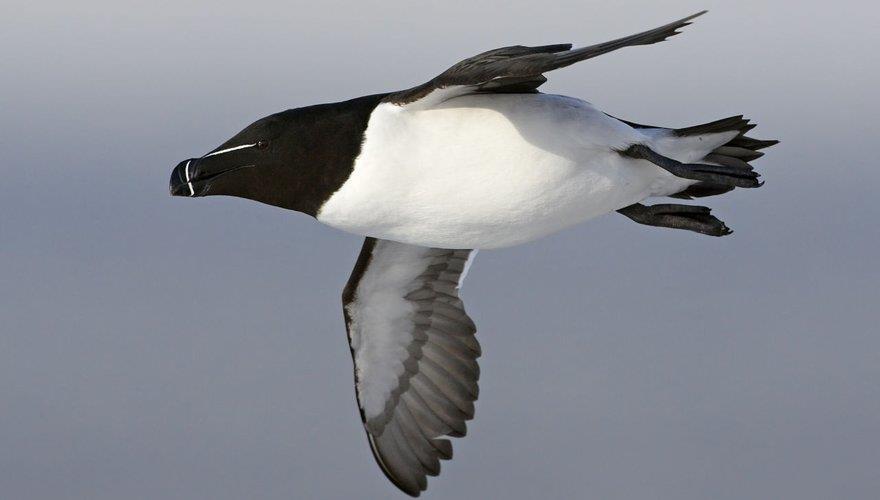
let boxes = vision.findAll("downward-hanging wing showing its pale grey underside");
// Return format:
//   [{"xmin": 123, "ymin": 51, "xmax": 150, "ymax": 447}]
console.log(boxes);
[{"xmin": 342, "ymin": 238, "xmax": 480, "ymax": 496}]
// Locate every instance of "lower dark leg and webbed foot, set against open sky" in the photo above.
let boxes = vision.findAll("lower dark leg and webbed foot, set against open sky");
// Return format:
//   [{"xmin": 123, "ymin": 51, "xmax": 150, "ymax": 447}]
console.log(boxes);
[{"xmin": 618, "ymin": 203, "xmax": 733, "ymax": 236}]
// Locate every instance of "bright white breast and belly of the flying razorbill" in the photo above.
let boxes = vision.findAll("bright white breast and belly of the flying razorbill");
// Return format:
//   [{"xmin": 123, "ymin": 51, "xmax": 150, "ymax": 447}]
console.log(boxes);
[{"xmin": 317, "ymin": 94, "xmax": 686, "ymax": 248}]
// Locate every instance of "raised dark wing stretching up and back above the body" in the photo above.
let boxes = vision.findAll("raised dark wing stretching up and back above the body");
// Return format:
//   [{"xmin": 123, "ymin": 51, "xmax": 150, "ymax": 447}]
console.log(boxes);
[{"xmin": 385, "ymin": 10, "xmax": 706, "ymax": 106}]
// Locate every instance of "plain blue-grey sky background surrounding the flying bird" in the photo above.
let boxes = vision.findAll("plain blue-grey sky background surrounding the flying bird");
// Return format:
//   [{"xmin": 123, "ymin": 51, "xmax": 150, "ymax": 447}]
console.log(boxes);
[{"xmin": 0, "ymin": 0, "xmax": 880, "ymax": 500}]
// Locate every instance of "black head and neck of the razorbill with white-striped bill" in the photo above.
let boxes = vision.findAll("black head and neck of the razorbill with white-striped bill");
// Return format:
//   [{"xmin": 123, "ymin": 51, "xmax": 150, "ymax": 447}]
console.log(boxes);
[{"xmin": 171, "ymin": 95, "xmax": 383, "ymax": 216}]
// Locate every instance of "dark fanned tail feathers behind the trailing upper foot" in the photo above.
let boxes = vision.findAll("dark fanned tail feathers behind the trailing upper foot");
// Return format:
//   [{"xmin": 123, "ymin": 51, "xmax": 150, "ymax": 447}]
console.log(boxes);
[{"xmin": 671, "ymin": 115, "xmax": 779, "ymax": 200}]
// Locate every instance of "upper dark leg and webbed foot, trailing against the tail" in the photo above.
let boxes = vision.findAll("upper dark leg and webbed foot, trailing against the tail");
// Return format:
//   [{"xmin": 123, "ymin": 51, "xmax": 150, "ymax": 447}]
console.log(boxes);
[{"xmin": 620, "ymin": 144, "xmax": 763, "ymax": 188}]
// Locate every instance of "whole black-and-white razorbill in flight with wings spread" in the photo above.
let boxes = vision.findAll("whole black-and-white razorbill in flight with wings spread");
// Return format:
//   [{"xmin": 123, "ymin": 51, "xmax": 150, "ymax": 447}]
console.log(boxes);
[{"xmin": 171, "ymin": 11, "xmax": 777, "ymax": 496}]
